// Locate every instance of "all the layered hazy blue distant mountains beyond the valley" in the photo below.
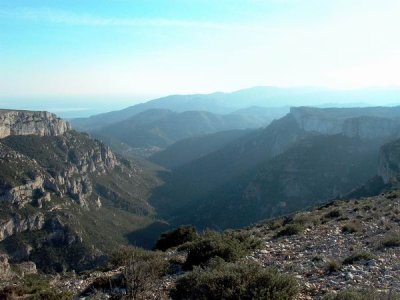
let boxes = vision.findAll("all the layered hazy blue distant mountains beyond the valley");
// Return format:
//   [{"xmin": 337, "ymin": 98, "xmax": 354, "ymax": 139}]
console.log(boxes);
[{"xmin": 71, "ymin": 87, "xmax": 400, "ymax": 157}]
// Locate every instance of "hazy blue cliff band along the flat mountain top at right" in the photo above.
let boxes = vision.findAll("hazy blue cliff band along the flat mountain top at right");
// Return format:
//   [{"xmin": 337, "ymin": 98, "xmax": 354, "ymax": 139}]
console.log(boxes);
[{"xmin": 290, "ymin": 107, "xmax": 400, "ymax": 139}]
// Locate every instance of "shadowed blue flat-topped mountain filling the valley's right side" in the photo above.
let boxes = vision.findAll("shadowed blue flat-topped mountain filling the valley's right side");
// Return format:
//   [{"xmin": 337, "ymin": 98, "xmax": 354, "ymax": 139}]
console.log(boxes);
[{"xmin": 151, "ymin": 107, "xmax": 400, "ymax": 228}]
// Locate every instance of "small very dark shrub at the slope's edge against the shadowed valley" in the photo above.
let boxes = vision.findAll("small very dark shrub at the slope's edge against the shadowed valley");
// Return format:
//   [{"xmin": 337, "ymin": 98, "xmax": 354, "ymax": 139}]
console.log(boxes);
[{"xmin": 154, "ymin": 225, "xmax": 198, "ymax": 251}]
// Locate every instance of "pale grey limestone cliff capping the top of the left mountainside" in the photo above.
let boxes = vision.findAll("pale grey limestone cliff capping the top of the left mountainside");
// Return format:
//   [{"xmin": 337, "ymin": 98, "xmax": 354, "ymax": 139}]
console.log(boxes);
[{"xmin": 0, "ymin": 110, "xmax": 71, "ymax": 138}]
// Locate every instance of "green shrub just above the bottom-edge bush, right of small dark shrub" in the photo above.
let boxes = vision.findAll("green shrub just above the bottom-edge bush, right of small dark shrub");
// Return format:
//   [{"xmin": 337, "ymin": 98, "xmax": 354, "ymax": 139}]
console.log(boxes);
[{"xmin": 184, "ymin": 231, "xmax": 261, "ymax": 269}]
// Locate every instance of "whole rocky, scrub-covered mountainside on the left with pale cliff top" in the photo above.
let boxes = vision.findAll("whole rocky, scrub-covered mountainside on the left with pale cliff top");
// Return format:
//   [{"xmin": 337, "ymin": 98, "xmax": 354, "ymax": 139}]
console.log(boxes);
[{"xmin": 0, "ymin": 111, "xmax": 157, "ymax": 272}]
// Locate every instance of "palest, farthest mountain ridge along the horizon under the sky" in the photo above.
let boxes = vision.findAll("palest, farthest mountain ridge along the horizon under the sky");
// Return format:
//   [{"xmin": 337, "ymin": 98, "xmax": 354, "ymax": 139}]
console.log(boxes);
[{"xmin": 71, "ymin": 86, "xmax": 400, "ymax": 131}]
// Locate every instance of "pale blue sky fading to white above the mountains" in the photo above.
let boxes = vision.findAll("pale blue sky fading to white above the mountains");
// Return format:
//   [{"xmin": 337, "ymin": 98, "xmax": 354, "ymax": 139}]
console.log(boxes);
[{"xmin": 0, "ymin": 0, "xmax": 400, "ymax": 116}]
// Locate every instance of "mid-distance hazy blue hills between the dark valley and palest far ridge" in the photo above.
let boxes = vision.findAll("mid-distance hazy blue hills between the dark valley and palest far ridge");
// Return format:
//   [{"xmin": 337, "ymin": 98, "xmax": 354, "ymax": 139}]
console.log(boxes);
[{"xmin": 91, "ymin": 109, "xmax": 276, "ymax": 155}]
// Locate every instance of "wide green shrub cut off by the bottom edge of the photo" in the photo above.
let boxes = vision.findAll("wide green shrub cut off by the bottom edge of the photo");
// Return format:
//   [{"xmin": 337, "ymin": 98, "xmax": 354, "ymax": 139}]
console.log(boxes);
[{"xmin": 170, "ymin": 262, "xmax": 299, "ymax": 300}]
